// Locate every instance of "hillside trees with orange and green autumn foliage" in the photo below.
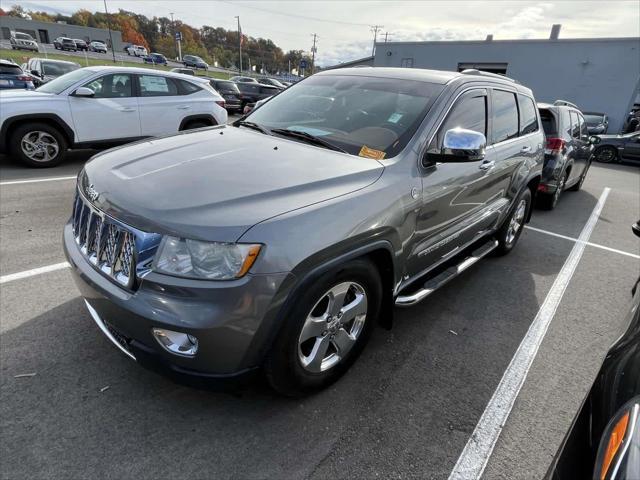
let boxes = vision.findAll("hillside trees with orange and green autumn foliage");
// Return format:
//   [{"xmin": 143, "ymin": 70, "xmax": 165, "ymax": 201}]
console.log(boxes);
[{"xmin": 2, "ymin": 5, "xmax": 311, "ymax": 74}]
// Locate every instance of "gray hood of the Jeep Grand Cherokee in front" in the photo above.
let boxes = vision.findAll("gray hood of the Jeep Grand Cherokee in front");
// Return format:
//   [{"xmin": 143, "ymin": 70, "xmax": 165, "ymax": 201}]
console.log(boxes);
[{"xmin": 79, "ymin": 127, "xmax": 384, "ymax": 242}]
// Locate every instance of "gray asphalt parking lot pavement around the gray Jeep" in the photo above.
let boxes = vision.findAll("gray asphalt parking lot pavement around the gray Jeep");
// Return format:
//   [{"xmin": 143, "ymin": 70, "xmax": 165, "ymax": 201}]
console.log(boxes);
[{"xmin": 0, "ymin": 144, "xmax": 640, "ymax": 479}]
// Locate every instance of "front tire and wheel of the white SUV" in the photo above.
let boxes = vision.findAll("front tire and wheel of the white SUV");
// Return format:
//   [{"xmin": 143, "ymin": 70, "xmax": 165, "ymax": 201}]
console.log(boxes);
[{"xmin": 9, "ymin": 122, "xmax": 67, "ymax": 168}]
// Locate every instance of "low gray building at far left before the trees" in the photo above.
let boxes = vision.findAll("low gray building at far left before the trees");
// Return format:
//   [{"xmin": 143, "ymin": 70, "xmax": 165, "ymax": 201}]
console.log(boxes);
[{"xmin": 0, "ymin": 15, "xmax": 123, "ymax": 52}]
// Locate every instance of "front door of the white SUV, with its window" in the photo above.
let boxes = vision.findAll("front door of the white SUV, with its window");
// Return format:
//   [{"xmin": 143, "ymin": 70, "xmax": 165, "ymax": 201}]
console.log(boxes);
[{"xmin": 69, "ymin": 73, "xmax": 141, "ymax": 142}]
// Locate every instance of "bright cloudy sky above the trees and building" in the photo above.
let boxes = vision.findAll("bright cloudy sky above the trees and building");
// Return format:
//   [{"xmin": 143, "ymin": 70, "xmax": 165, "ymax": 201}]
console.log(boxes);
[{"xmin": 13, "ymin": 0, "xmax": 640, "ymax": 65}]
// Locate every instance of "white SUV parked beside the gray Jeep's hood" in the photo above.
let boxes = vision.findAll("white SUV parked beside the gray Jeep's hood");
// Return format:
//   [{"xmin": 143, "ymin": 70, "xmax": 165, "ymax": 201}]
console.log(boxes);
[{"xmin": 0, "ymin": 67, "xmax": 227, "ymax": 167}]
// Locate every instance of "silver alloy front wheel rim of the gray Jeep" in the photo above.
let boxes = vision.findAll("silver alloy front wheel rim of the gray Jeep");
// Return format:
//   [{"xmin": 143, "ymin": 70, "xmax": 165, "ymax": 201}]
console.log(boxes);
[{"xmin": 298, "ymin": 282, "xmax": 367, "ymax": 373}]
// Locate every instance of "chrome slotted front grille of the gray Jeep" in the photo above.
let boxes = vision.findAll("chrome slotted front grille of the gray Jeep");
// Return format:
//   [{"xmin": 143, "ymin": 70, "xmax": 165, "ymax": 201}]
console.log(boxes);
[{"xmin": 72, "ymin": 194, "xmax": 137, "ymax": 289}]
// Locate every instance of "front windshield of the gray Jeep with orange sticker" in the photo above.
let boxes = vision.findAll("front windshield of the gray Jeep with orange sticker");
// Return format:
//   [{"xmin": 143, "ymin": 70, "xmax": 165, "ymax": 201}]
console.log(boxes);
[{"xmin": 247, "ymin": 75, "xmax": 443, "ymax": 158}]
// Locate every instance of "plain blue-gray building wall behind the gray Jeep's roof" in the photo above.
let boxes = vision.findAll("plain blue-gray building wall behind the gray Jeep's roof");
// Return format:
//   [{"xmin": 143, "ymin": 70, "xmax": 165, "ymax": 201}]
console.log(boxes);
[{"xmin": 374, "ymin": 38, "xmax": 640, "ymax": 133}]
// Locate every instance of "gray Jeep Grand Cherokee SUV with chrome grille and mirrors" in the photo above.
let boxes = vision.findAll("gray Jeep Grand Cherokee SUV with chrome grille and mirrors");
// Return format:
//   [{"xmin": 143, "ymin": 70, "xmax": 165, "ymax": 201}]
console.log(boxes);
[{"xmin": 64, "ymin": 68, "xmax": 544, "ymax": 395}]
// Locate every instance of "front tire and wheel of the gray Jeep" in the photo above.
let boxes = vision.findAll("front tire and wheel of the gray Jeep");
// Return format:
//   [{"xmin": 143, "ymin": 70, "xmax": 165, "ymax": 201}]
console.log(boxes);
[{"xmin": 264, "ymin": 259, "xmax": 382, "ymax": 397}]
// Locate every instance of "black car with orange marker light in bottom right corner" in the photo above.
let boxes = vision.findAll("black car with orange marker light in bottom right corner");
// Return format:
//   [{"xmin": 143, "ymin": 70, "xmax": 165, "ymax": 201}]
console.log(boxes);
[{"xmin": 547, "ymin": 223, "xmax": 640, "ymax": 480}]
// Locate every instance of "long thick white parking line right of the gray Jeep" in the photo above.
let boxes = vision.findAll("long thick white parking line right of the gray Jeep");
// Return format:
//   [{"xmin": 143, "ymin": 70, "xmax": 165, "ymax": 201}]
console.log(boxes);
[{"xmin": 449, "ymin": 187, "xmax": 611, "ymax": 480}]
